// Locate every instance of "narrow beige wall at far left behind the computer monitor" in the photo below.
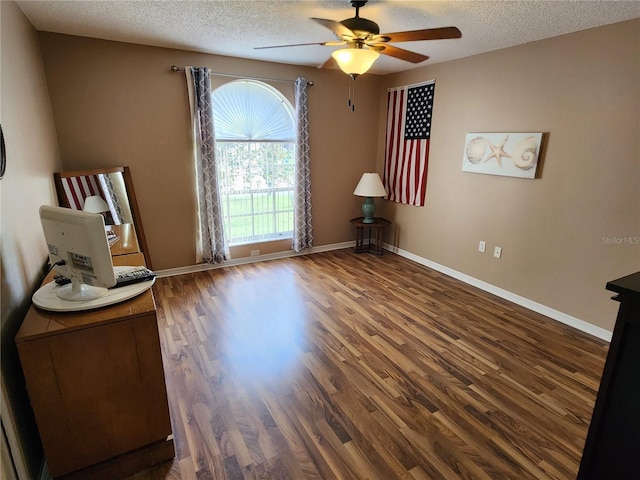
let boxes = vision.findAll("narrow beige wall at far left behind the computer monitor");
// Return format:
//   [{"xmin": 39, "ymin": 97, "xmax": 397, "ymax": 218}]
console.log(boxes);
[{"xmin": 0, "ymin": 1, "xmax": 60, "ymax": 479}]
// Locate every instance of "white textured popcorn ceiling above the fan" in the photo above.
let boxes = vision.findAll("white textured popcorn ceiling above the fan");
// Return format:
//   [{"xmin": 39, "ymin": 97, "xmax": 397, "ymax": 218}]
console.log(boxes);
[{"xmin": 17, "ymin": 0, "xmax": 640, "ymax": 74}]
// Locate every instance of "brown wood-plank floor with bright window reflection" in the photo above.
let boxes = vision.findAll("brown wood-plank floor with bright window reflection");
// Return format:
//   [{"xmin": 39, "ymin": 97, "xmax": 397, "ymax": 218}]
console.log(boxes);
[{"xmin": 127, "ymin": 249, "xmax": 608, "ymax": 480}]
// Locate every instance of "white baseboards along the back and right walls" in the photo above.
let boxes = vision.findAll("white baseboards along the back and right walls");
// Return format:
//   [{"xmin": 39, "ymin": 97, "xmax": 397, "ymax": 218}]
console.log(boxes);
[{"xmin": 156, "ymin": 241, "xmax": 613, "ymax": 342}]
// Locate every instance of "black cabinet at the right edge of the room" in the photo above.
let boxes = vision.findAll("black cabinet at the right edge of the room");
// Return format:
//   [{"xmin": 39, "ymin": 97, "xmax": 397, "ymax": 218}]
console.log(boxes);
[{"xmin": 578, "ymin": 272, "xmax": 640, "ymax": 480}]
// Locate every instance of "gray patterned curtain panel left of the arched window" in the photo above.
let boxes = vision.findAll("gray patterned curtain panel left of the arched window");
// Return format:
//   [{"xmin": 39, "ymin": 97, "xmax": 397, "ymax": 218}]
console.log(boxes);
[{"xmin": 185, "ymin": 67, "xmax": 229, "ymax": 263}]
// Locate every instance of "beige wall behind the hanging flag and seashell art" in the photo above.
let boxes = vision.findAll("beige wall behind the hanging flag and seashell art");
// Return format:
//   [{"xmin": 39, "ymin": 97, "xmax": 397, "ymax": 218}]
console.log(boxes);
[{"xmin": 378, "ymin": 20, "xmax": 640, "ymax": 330}]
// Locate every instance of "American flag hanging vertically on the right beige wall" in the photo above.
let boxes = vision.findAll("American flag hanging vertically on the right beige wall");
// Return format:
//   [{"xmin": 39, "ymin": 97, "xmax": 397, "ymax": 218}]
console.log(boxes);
[{"xmin": 384, "ymin": 80, "xmax": 436, "ymax": 207}]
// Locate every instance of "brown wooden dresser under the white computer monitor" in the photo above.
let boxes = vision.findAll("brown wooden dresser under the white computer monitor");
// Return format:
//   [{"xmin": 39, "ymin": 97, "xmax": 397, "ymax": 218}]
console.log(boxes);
[{"xmin": 15, "ymin": 253, "xmax": 174, "ymax": 480}]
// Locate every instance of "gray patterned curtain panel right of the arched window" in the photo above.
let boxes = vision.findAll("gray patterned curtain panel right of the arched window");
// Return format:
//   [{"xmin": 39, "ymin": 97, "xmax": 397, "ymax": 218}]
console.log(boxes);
[{"xmin": 291, "ymin": 77, "xmax": 313, "ymax": 252}]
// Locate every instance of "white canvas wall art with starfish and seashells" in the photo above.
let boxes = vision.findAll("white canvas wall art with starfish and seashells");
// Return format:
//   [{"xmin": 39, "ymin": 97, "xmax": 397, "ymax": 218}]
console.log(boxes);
[{"xmin": 462, "ymin": 132, "xmax": 542, "ymax": 178}]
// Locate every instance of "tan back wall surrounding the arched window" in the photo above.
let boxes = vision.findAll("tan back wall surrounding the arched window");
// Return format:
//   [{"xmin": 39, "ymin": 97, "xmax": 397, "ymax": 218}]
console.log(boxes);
[{"xmin": 40, "ymin": 33, "xmax": 379, "ymax": 270}]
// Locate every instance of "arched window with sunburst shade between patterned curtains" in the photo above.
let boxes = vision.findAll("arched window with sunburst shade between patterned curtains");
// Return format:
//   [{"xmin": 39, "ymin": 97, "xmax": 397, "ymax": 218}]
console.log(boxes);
[{"xmin": 211, "ymin": 80, "xmax": 295, "ymax": 245}]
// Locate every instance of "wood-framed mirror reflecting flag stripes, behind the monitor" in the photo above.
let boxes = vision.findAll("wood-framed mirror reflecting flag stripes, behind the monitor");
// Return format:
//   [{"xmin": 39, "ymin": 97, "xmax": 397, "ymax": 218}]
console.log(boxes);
[{"xmin": 53, "ymin": 167, "xmax": 153, "ymax": 269}]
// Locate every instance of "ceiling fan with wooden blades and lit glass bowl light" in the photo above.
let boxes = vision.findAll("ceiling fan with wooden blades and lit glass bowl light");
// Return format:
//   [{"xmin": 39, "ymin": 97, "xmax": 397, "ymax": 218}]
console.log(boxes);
[{"xmin": 255, "ymin": 0, "xmax": 462, "ymax": 78}]
